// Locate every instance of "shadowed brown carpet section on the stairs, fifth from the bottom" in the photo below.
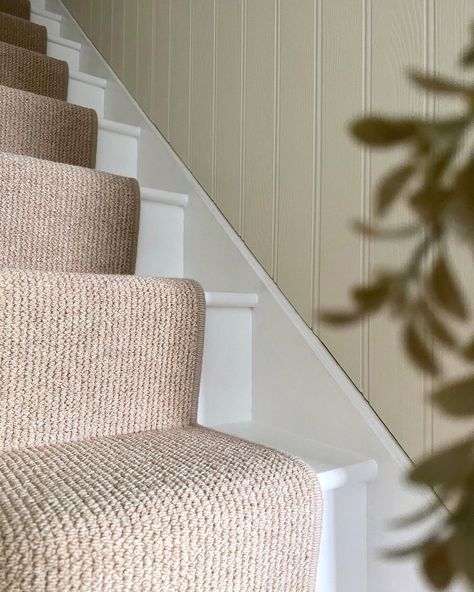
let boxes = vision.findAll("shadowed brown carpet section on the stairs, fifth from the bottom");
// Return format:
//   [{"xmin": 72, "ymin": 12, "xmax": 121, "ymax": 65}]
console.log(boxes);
[{"xmin": 0, "ymin": 41, "xmax": 69, "ymax": 101}]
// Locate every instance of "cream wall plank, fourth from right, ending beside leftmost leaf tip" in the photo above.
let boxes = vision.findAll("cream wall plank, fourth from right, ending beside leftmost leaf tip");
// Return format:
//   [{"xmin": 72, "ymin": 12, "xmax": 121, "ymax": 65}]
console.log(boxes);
[{"xmin": 276, "ymin": 0, "xmax": 319, "ymax": 324}]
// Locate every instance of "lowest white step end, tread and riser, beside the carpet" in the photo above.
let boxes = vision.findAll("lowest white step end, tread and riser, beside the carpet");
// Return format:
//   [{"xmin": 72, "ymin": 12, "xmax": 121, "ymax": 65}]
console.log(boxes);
[{"xmin": 212, "ymin": 421, "xmax": 377, "ymax": 592}]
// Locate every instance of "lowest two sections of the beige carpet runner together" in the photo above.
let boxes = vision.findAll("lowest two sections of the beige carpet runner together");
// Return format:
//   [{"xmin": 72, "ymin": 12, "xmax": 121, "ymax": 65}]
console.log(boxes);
[{"xmin": 0, "ymin": 271, "xmax": 321, "ymax": 592}]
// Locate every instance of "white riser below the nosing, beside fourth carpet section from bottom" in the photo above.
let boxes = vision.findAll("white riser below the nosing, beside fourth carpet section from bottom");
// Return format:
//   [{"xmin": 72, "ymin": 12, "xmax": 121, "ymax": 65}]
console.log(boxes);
[{"xmin": 96, "ymin": 127, "xmax": 138, "ymax": 177}]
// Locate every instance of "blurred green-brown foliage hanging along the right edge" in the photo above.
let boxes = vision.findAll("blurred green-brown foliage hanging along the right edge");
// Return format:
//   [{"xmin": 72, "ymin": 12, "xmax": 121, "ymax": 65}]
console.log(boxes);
[{"xmin": 322, "ymin": 22, "xmax": 474, "ymax": 590}]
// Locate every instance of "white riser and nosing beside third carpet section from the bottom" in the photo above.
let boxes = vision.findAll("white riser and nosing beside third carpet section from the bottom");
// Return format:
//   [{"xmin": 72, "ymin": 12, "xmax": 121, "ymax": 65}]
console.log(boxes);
[{"xmin": 136, "ymin": 187, "xmax": 188, "ymax": 277}]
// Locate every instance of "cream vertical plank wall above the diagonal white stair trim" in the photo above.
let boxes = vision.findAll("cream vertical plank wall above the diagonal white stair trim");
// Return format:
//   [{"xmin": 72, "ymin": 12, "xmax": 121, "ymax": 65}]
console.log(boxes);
[{"xmin": 66, "ymin": 0, "xmax": 474, "ymax": 457}]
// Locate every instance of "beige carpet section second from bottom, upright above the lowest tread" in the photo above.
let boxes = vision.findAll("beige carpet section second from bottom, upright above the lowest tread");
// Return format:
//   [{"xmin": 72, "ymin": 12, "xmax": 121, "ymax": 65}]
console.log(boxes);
[{"xmin": 0, "ymin": 270, "xmax": 205, "ymax": 450}]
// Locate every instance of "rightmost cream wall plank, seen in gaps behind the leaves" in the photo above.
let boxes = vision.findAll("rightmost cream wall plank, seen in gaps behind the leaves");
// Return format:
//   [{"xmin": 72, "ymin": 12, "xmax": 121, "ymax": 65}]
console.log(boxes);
[{"xmin": 433, "ymin": 0, "xmax": 474, "ymax": 448}]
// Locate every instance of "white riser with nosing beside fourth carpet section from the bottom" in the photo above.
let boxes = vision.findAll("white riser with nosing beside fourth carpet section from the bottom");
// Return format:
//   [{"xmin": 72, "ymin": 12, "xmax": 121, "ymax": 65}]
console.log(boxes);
[{"xmin": 96, "ymin": 119, "xmax": 141, "ymax": 177}]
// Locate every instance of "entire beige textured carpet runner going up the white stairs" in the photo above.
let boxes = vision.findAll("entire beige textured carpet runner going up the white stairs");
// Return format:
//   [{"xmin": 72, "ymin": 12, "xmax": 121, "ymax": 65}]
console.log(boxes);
[{"xmin": 0, "ymin": 0, "xmax": 322, "ymax": 592}]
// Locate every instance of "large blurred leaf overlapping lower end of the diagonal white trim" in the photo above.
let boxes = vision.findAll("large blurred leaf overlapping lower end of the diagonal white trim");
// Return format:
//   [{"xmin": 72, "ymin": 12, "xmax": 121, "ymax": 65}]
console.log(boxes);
[{"xmin": 409, "ymin": 441, "xmax": 473, "ymax": 487}]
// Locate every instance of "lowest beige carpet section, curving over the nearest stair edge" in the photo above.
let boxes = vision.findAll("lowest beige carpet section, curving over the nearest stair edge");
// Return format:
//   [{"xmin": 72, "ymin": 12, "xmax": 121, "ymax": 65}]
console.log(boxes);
[{"xmin": 0, "ymin": 428, "xmax": 321, "ymax": 592}]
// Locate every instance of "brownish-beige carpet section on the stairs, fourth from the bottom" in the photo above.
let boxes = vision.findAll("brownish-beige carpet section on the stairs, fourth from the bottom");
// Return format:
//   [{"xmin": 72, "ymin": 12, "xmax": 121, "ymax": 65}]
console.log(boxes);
[{"xmin": 0, "ymin": 86, "xmax": 97, "ymax": 168}]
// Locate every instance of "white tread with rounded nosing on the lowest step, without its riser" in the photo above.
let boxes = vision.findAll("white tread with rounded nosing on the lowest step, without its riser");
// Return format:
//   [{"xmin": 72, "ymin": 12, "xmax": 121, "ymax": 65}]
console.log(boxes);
[{"xmin": 217, "ymin": 421, "xmax": 377, "ymax": 491}]
